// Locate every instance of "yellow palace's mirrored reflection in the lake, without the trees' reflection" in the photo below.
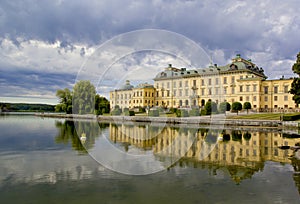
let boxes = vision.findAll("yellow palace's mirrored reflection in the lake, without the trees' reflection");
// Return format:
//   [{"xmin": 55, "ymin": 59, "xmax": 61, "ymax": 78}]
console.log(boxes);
[{"xmin": 109, "ymin": 123, "xmax": 300, "ymax": 183}]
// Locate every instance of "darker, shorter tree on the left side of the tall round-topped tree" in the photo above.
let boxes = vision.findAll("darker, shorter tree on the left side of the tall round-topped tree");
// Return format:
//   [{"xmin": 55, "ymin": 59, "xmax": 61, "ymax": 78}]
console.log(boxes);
[{"xmin": 55, "ymin": 88, "xmax": 72, "ymax": 114}]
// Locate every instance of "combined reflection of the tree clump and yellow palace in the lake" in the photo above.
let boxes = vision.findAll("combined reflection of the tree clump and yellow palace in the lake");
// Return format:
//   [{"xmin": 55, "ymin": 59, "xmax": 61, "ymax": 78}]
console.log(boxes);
[{"xmin": 55, "ymin": 121, "xmax": 300, "ymax": 183}]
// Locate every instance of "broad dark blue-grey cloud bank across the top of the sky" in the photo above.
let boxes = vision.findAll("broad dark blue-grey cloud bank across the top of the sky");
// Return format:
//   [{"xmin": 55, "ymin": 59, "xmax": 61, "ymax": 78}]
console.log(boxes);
[{"xmin": 0, "ymin": 0, "xmax": 300, "ymax": 58}]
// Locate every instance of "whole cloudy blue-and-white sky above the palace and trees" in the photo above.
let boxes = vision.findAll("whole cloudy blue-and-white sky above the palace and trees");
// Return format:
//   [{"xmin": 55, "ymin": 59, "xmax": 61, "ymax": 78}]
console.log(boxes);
[{"xmin": 0, "ymin": 0, "xmax": 300, "ymax": 104}]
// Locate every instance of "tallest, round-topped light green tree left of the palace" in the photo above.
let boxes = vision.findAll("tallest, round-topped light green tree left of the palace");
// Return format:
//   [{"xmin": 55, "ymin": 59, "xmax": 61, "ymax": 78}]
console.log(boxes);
[{"xmin": 73, "ymin": 80, "xmax": 96, "ymax": 114}]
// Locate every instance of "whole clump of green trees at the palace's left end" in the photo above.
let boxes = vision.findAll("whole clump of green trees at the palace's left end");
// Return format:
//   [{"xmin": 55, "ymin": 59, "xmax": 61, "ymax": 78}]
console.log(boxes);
[{"xmin": 55, "ymin": 80, "xmax": 110, "ymax": 115}]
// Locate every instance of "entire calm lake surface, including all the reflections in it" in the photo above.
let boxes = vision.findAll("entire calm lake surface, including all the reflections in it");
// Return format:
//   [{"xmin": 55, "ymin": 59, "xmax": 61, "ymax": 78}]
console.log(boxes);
[{"xmin": 0, "ymin": 116, "xmax": 300, "ymax": 204}]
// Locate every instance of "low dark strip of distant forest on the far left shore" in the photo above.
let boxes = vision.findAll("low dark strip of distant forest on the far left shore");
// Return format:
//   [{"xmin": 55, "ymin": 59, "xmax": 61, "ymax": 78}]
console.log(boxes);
[{"xmin": 0, "ymin": 102, "xmax": 55, "ymax": 112}]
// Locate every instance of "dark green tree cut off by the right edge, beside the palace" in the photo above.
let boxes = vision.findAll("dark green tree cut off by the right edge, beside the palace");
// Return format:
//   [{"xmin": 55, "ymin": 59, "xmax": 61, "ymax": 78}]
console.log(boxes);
[{"xmin": 290, "ymin": 52, "xmax": 300, "ymax": 105}]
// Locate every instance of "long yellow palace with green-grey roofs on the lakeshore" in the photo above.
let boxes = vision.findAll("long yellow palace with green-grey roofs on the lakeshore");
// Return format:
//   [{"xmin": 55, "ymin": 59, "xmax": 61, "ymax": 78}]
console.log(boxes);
[{"xmin": 110, "ymin": 55, "xmax": 296, "ymax": 111}]
